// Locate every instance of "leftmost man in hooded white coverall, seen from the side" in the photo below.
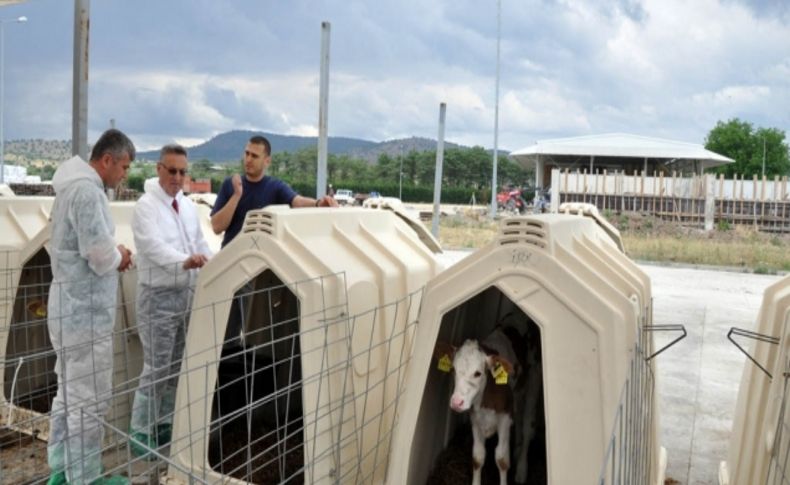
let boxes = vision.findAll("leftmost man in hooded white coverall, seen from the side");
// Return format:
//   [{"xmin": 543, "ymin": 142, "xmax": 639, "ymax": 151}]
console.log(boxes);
[{"xmin": 47, "ymin": 129, "xmax": 135, "ymax": 485}]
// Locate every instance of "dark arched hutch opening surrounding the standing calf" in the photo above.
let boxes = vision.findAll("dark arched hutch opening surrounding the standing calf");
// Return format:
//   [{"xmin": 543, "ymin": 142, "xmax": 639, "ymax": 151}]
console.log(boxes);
[{"xmin": 430, "ymin": 286, "xmax": 547, "ymax": 485}]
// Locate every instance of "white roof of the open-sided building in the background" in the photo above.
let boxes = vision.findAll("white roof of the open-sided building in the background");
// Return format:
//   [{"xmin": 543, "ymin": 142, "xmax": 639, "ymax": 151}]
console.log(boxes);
[{"xmin": 510, "ymin": 133, "xmax": 735, "ymax": 170}]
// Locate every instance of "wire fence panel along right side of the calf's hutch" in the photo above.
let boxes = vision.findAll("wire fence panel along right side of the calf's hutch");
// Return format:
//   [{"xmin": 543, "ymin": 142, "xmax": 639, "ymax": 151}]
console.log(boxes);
[{"xmin": 598, "ymin": 330, "xmax": 658, "ymax": 485}]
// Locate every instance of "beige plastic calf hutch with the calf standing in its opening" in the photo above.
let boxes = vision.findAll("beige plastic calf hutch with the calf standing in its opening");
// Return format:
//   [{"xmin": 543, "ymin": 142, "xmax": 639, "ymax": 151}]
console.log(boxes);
[{"xmin": 387, "ymin": 214, "xmax": 664, "ymax": 485}]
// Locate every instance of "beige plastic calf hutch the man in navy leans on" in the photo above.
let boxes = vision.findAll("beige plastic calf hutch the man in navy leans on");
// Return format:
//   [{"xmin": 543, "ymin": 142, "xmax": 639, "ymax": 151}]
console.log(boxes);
[{"xmin": 166, "ymin": 206, "xmax": 442, "ymax": 483}]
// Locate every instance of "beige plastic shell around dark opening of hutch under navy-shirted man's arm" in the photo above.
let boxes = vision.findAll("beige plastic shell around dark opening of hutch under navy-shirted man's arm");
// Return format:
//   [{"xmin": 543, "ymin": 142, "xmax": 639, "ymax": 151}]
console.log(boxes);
[{"xmin": 168, "ymin": 206, "xmax": 442, "ymax": 483}]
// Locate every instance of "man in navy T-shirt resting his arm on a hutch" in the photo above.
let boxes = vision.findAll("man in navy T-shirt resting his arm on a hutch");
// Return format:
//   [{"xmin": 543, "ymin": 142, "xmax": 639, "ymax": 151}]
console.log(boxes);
[{"xmin": 211, "ymin": 136, "xmax": 337, "ymax": 247}]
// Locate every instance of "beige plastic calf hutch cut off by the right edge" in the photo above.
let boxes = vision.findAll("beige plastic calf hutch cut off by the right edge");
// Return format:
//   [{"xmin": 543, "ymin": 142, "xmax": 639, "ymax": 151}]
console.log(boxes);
[{"xmin": 719, "ymin": 276, "xmax": 790, "ymax": 485}]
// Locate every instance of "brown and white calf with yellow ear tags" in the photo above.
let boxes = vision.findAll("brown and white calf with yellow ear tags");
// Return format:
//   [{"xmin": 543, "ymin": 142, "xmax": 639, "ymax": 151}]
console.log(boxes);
[{"xmin": 436, "ymin": 326, "xmax": 521, "ymax": 485}]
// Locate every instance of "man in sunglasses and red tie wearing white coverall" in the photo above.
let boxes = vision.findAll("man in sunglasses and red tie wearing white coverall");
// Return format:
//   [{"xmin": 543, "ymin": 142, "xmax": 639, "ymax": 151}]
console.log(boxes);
[{"xmin": 130, "ymin": 144, "xmax": 211, "ymax": 458}]
